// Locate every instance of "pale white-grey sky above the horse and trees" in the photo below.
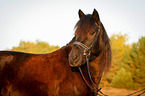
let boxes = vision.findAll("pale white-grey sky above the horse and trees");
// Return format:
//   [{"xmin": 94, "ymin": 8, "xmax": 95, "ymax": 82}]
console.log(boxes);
[{"xmin": 0, "ymin": 0, "xmax": 145, "ymax": 50}]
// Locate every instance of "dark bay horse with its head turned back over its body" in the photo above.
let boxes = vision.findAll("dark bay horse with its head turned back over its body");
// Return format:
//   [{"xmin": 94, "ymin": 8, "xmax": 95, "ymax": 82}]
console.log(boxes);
[{"xmin": 0, "ymin": 9, "xmax": 111, "ymax": 96}]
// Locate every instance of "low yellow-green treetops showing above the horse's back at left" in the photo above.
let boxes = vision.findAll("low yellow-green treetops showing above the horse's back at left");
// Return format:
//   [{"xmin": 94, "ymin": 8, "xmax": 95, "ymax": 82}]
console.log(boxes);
[{"xmin": 12, "ymin": 40, "xmax": 59, "ymax": 54}]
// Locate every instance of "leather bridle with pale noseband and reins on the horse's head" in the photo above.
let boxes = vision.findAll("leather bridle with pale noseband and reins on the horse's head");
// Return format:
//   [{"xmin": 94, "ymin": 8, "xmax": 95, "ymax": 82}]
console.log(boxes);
[{"xmin": 74, "ymin": 26, "xmax": 107, "ymax": 96}]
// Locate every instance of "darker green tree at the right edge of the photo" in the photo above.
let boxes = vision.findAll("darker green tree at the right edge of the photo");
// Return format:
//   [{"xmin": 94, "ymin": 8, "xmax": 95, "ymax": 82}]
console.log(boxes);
[{"xmin": 122, "ymin": 37, "xmax": 145, "ymax": 89}]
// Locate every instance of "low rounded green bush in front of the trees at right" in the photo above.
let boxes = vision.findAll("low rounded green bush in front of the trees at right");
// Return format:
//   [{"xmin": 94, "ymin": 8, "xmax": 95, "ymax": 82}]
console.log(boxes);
[{"xmin": 112, "ymin": 68, "xmax": 133, "ymax": 89}]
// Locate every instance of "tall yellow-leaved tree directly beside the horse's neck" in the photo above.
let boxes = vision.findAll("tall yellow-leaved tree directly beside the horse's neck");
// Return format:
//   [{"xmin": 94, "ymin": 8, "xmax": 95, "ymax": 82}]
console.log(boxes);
[{"xmin": 101, "ymin": 33, "xmax": 130, "ymax": 87}]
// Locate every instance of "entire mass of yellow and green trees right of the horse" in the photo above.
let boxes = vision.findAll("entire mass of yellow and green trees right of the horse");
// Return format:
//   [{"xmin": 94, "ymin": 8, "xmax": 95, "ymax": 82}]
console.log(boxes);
[{"xmin": 101, "ymin": 34, "xmax": 145, "ymax": 89}]
